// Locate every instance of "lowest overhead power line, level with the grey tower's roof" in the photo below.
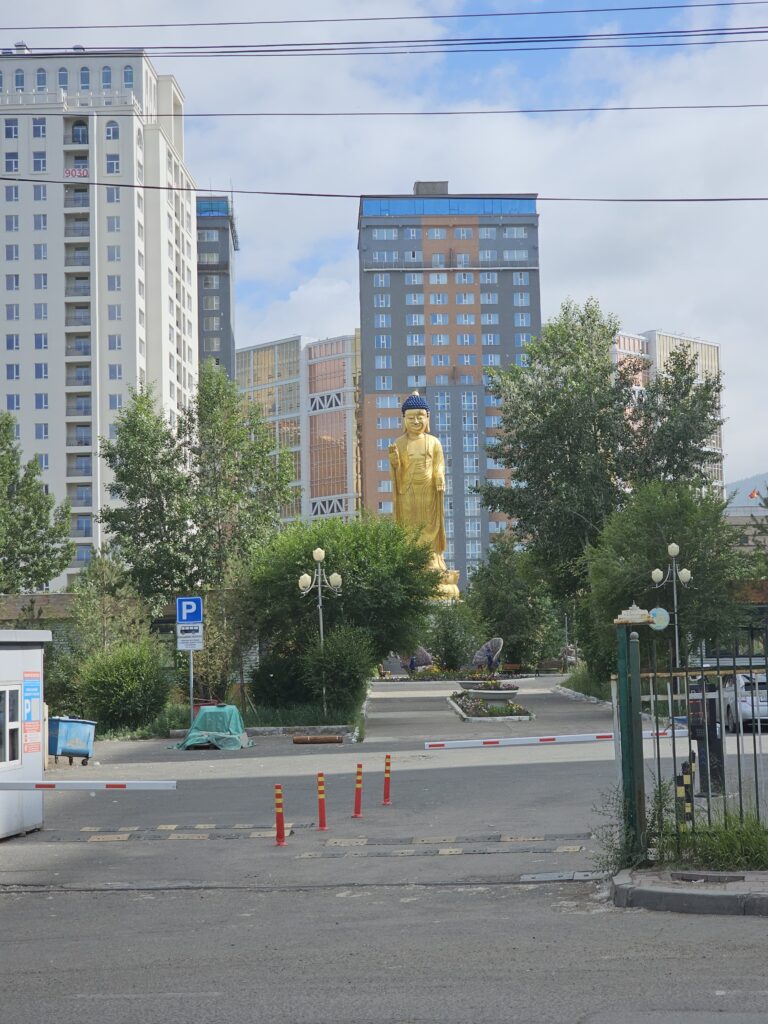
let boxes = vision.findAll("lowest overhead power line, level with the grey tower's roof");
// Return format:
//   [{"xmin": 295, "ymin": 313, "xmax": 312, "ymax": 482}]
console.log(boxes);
[{"xmin": 0, "ymin": 174, "xmax": 768, "ymax": 204}]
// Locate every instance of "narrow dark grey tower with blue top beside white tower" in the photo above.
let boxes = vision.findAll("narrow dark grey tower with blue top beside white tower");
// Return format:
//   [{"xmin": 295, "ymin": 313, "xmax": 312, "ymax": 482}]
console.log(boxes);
[{"xmin": 197, "ymin": 196, "xmax": 240, "ymax": 379}]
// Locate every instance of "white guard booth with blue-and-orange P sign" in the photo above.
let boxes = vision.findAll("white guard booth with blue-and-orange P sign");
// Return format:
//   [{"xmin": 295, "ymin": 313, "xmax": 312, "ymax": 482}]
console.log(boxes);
[{"xmin": 0, "ymin": 630, "xmax": 51, "ymax": 839}]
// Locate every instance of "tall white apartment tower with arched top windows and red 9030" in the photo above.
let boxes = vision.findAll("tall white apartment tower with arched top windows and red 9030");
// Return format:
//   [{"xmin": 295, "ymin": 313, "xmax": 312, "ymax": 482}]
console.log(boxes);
[{"xmin": 0, "ymin": 43, "xmax": 198, "ymax": 587}]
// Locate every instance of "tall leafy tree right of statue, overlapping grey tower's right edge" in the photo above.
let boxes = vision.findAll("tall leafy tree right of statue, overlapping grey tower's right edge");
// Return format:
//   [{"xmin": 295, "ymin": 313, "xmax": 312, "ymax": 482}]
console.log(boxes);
[{"xmin": 482, "ymin": 299, "xmax": 638, "ymax": 597}]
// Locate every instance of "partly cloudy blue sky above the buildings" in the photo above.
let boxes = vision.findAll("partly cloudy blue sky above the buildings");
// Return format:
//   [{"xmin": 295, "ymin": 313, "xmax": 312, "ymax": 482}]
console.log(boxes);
[{"xmin": 10, "ymin": 0, "xmax": 768, "ymax": 480}]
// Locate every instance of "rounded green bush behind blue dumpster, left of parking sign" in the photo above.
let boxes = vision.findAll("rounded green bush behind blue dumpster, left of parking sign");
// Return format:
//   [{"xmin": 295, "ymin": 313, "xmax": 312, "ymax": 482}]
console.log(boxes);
[{"xmin": 78, "ymin": 640, "xmax": 168, "ymax": 730}]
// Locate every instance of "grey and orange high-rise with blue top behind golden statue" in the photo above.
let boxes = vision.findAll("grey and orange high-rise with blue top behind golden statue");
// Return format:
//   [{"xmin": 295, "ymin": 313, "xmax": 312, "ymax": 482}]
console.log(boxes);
[{"xmin": 358, "ymin": 181, "xmax": 541, "ymax": 585}]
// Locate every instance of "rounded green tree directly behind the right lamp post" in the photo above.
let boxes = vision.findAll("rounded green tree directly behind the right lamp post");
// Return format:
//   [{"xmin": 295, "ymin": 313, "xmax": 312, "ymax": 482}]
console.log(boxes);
[{"xmin": 583, "ymin": 482, "xmax": 754, "ymax": 678}]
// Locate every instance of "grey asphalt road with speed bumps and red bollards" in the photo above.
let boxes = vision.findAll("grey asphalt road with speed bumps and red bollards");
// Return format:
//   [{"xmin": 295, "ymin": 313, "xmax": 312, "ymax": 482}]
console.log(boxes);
[{"xmin": 0, "ymin": 680, "xmax": 768, "ymax": 1024}]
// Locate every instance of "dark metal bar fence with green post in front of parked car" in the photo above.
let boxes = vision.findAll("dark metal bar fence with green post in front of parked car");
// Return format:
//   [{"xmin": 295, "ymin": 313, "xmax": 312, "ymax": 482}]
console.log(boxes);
[{"xmin": 640, "ymin": 627, "xmax": 768, "ymax": 847}]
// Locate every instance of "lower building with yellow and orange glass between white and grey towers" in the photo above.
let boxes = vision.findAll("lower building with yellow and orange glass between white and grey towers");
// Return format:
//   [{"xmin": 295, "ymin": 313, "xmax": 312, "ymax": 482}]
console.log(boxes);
[{"xmin": 236, "ymin": 332, "xmax": 360, "ymax": 521}]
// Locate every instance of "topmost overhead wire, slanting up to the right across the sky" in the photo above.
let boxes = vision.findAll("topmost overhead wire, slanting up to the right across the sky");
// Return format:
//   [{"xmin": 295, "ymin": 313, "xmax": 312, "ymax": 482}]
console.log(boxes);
[{"xmin": 4, "ymin": 0, "xmax": 768, "ymax": 32}]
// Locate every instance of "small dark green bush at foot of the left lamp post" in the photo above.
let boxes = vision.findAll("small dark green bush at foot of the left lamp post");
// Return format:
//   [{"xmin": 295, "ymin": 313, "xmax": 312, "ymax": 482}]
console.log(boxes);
[{"xmin": 300, "ymin": 626, "xmax": 376, "ymax": 712}]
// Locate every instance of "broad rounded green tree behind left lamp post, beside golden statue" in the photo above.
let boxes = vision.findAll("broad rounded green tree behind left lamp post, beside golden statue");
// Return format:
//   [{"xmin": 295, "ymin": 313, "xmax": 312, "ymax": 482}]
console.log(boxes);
[{"xmin": 242, "ymin": 515, "xmax": 439, "ymax": 660}]
